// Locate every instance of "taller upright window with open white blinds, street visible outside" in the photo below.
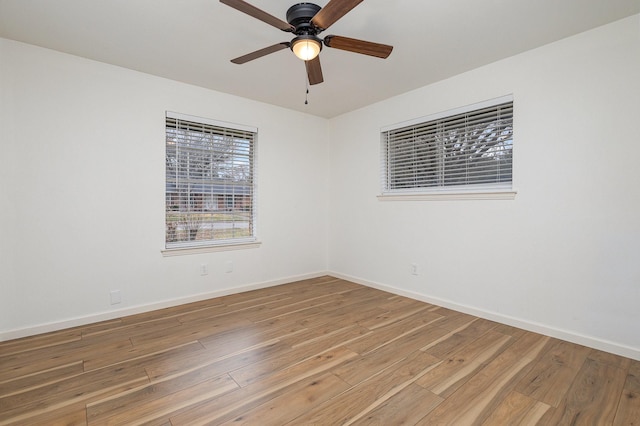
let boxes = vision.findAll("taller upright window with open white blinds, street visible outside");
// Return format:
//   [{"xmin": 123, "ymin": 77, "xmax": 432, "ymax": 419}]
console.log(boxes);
[{"xmin": 165, "ymin": 112, "xmax": 256, "ymax": 249}]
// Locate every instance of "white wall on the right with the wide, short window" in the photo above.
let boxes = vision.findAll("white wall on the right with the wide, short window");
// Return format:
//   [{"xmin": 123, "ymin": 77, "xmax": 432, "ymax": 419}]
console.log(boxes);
[{"xmin": 329, "ymin": 16, "xmax": 640, "ymax": 359}]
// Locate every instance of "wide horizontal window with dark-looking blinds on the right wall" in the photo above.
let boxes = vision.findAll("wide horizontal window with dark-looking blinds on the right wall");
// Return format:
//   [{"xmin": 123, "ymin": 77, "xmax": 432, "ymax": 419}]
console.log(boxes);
[{"xmin": 382, "ymin": 97, "xmax": 513, "ymax": 197}]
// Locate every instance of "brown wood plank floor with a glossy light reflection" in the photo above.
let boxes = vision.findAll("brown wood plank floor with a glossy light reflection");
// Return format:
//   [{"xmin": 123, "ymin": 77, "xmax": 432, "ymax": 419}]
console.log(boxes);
[{"xmin": 0, "ymin": 277, "xmax": 640, "ymax": 426}]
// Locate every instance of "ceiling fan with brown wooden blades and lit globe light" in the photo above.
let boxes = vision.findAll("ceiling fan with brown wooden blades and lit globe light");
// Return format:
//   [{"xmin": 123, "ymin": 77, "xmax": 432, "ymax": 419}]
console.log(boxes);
[{"xmin": 220, "ymin": 0, "xmax": 393, "ymax": 85}]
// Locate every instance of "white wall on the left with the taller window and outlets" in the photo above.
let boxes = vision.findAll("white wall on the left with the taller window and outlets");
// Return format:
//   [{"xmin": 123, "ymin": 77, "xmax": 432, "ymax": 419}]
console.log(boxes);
[{"xmin": 0, "ymin": 39, "xmax": 328, "ymax": 340}]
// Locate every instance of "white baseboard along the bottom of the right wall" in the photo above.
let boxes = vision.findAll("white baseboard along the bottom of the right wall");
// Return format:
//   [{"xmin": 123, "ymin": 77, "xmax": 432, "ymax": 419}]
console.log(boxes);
[{"xmin": 327, "ymin": 271, "xmax": 640, "ymax": 361}]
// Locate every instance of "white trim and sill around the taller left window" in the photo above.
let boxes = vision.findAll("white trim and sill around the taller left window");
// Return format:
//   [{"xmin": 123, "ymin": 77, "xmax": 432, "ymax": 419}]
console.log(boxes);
[{"xmin": 160, "ymin": 110, "xmax": 262, "ymax": 253}]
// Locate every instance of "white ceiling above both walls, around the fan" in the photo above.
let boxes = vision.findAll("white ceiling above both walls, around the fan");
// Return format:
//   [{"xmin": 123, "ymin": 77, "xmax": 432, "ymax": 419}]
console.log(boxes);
[{"xmin": 0, "ymin": 0, "xmax": 640, "ymax": 118}]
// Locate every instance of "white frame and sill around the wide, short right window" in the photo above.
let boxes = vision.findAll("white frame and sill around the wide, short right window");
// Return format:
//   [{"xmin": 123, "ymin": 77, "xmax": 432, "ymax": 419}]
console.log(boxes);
[{"xmin": 378, "ymin": 95, "xmax": 517, "ymax": 201}]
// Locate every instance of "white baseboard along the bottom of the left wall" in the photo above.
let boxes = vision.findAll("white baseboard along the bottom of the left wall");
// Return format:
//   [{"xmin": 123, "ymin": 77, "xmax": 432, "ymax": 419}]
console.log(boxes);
[{"xmin": 0, "ymin": 271, "xmax": 328, "ymax": 342}]
